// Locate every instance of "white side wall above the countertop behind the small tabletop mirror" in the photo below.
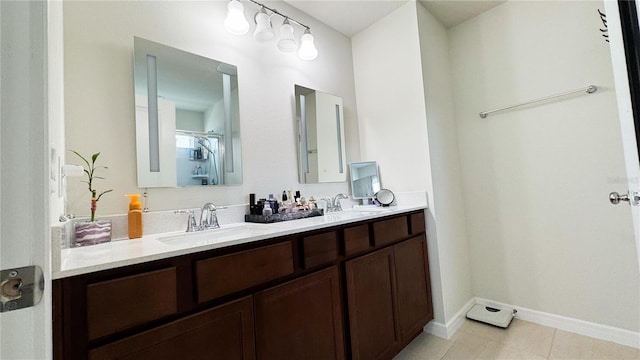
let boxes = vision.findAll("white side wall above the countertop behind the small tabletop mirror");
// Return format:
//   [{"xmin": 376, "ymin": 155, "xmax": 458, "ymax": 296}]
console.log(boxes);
[{"xmin": 351, "ymin": 3, "xmax": 431, "ymax": 191}]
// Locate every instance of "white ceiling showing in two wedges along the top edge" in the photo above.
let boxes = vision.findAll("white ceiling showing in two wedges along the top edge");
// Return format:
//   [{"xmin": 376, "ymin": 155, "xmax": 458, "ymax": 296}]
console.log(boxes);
[{"xmin": 285, "ymin": 0, "xmax": 505, "ymax": 37}]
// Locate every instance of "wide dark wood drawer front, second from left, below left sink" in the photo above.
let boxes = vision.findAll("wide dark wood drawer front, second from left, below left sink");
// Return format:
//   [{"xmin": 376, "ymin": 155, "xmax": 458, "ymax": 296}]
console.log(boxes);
[{"xmin": 195, "ymin": 241, "xmax": 293, "ymax": 303}]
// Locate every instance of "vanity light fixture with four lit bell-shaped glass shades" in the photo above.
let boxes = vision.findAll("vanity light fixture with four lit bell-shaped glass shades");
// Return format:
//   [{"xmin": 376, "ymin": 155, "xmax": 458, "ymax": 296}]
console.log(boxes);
[{"xmin": 224, "ymin": 0, "xmax": 318, "ymax": 60}]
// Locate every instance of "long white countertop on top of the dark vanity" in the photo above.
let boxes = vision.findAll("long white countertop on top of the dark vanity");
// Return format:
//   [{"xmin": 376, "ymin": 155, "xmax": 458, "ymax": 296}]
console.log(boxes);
[{"xmin": 52, "ymin": 204, "xmax": 427, "ymax": 279}]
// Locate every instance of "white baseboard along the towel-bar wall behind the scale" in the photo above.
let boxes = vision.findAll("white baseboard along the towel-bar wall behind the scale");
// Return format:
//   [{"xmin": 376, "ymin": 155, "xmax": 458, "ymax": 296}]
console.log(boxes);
[{"xmin": 475, "ymin": 298, "xmax": 640, "ymax": 348}]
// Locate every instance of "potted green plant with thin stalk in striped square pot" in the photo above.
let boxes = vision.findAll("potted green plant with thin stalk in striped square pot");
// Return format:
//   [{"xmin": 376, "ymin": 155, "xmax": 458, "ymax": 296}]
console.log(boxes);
[{"xmin": 70, "ymin": 150, "xmax": 113, "ymax": 246}]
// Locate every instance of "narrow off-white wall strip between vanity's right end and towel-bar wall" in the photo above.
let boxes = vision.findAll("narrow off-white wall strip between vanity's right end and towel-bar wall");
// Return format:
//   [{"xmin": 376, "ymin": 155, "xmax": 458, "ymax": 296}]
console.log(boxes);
[{"xmin": 417, "ymin": 3, "xmax": 473, "ymax": 321}]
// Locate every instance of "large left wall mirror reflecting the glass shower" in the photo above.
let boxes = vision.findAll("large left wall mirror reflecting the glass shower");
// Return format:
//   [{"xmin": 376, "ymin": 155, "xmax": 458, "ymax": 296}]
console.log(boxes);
[{"xmin": 134, "ymin": 37, "xmax": 242, "ymax": 187}]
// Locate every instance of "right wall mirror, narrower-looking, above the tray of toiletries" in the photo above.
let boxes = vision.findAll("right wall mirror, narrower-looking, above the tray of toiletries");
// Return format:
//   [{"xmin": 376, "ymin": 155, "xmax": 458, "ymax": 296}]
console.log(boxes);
[{"xmin": 294, "ymin": 85, "xmax": 347, "ymax": 184}]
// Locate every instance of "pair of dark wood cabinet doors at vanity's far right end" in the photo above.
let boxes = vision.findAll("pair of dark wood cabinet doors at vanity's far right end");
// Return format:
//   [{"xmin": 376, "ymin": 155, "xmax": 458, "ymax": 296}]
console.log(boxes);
[{"xmin": 345, "ymin": 234, "xmax": 433, "ymax": 360}]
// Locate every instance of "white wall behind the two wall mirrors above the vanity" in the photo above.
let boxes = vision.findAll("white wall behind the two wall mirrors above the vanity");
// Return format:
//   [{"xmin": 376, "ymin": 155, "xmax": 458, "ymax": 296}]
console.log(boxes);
[{"xmin": 64, "ymin": 1, "xmax": 360, "ymax": 215}]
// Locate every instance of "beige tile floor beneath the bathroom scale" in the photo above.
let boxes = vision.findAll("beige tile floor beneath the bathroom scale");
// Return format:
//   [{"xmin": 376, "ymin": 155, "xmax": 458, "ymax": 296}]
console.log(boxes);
[{"xmin": 394, "ymin": 319, "xmax": 640, "ymax": 360}]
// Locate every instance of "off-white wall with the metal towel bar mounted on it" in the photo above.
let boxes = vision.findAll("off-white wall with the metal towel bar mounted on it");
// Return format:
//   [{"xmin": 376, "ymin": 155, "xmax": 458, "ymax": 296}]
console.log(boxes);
[{"xmin": 450, "ymin": 1, "xmax": 640, "ymax": 332}]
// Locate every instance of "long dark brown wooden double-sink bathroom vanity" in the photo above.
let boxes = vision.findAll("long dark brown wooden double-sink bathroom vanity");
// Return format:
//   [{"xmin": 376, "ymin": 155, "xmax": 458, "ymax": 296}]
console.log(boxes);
[{"xmin": 53, "ymin": 208, "xmax": 433, "ymax": 360}]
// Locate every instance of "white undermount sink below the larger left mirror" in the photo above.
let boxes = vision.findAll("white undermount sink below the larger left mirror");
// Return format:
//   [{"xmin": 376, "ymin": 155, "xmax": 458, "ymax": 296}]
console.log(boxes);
[{"xmin": 158, "ymin": 223, "xmax": 277, "ymax": 246}]
